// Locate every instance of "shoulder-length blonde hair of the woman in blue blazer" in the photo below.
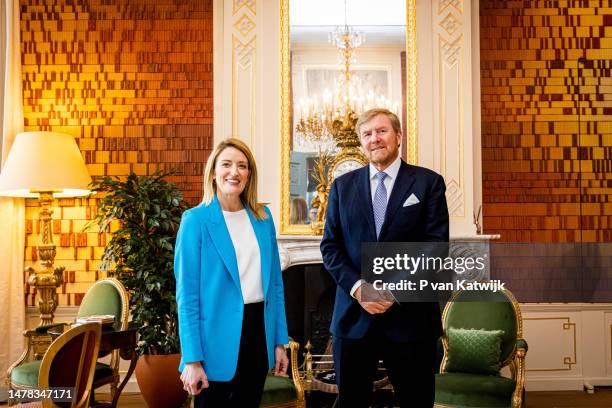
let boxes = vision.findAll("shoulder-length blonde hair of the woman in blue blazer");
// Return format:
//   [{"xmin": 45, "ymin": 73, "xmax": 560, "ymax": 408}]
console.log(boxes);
[{"xmin": 202, "ymin": 137, "xmax": 268, "ymax": 220}]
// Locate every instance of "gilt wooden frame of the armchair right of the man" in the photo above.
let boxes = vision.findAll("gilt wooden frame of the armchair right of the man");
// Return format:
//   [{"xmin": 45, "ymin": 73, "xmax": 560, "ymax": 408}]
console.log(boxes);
[{"xmin": 435, "ymin": 289, "xmax": 527, "ymax": 408}]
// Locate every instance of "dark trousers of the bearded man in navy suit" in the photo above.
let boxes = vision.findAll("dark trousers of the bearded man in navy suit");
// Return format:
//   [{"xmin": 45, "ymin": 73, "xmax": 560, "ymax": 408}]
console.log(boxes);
[{"xmin": 333, "ymin": 324, "xmax": 436, "ymax": 408}]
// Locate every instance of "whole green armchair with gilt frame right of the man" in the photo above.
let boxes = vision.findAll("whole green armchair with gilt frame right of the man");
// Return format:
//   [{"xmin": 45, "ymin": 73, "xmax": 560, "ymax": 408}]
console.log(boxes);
[{"xmin": 435, "ymin": 290, "xmax": 527, "ymax": 408}]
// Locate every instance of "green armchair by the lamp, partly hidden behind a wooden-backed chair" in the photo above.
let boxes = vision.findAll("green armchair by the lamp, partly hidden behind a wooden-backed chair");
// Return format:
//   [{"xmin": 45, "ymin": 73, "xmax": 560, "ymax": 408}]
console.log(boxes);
[{"xmin": 7, "ymin": 278, "xmax": 129, "ymax": 408}]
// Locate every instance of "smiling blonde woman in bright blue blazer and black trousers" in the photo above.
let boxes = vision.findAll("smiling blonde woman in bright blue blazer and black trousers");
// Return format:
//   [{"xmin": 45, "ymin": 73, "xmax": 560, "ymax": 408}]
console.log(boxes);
[{"xmin": 174, "ymin": 139, "xmax": 288, "ymax": 408}]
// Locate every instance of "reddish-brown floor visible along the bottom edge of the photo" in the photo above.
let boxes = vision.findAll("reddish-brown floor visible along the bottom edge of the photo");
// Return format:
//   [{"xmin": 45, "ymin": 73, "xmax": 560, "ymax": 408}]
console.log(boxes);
[{"xmin": 0, "ymin": 388, "xmax": 612, "ymax": 408}]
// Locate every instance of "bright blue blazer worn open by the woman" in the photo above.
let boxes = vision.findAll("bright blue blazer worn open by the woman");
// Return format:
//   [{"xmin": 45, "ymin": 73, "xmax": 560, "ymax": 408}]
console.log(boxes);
[{"xmin": 174, "ymin": 197, "xmax": 289, "ymax": 381}]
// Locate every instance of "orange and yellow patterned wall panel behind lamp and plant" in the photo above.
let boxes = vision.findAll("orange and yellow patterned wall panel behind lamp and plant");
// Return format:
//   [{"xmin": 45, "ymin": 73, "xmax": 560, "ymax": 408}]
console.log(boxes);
[{"xmin": 20, "ymin": 0, "xmax": 213, "ymax": 305}]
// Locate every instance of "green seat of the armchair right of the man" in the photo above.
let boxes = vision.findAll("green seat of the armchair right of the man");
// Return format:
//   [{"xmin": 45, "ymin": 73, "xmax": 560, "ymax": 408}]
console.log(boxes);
[{"xmin": 436, "ymin": 373, "xmax": 516, "ymax": 408}]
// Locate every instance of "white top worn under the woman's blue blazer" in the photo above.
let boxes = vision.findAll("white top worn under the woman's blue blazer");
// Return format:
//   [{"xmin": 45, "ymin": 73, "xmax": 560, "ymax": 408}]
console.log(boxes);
[{"xmin": 223, "ymin": 209, "xmax": 263, "ymax": 304}]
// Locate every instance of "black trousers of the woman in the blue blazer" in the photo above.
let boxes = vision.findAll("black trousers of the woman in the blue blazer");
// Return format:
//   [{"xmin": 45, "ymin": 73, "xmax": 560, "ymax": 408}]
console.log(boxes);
[{"xmin": 194, "ymin": 302, "xmax": 268, "ymax": 408}]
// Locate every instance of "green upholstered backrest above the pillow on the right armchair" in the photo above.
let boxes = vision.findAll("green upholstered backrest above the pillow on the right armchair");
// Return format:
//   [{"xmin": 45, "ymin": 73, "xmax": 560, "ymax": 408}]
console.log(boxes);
[{"xmin": 444, "ymin": 290, "xmax": 517, "ymax": 361}]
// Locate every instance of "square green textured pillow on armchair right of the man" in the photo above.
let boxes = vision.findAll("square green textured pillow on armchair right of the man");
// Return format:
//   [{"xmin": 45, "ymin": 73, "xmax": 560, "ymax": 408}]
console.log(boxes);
[{"xmin": 444, "ymin": 327, "xmax": 504, "ymax": 374}]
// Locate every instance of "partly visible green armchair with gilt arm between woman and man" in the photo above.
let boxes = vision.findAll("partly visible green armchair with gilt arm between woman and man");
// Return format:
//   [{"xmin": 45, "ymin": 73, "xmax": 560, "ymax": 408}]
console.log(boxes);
[{"xmin": 260, "ymin": 340, "xmax": 306, "ymax": 408}]
